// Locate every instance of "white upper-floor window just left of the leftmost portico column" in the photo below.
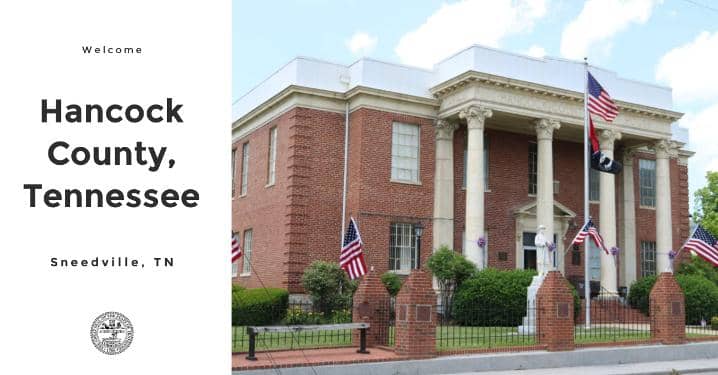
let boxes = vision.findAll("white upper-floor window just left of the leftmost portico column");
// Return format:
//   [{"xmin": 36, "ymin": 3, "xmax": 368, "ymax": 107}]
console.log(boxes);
[{"xmin": 391, "ymin": 122, "xmax": 421, "ymax": 185}]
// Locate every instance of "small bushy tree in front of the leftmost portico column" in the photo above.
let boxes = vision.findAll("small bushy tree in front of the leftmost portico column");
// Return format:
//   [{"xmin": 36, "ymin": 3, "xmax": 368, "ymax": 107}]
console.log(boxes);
[{"xmin": 426, "ymin": 246, "xmax": 476, "ymax": 317}]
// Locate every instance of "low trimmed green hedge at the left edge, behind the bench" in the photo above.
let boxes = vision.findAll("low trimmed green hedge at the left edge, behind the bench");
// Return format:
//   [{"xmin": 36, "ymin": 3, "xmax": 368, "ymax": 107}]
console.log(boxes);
[{"xmin": 232, "ymin": 287, "xmax": 289, "ymax": 326}]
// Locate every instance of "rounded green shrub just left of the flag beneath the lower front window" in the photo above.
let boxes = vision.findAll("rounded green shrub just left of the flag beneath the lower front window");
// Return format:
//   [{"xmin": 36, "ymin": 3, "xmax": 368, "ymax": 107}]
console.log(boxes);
[{"xmin": 302, "ymin": 261, "xmax": 357, "ymax": 316}]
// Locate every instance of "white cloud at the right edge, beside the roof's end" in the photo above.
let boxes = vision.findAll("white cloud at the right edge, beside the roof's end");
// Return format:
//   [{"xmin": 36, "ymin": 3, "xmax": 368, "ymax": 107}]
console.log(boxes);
[{"xmin": 656, "ymin": 32, "xmax": 718, "ymax": 102}]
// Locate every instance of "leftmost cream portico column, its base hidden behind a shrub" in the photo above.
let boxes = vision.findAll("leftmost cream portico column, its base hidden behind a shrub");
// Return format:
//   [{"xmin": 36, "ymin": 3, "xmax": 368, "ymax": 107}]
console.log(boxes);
[{"xmin": 432, "ymin": 120, "xmax": 459, "ymax": 251}]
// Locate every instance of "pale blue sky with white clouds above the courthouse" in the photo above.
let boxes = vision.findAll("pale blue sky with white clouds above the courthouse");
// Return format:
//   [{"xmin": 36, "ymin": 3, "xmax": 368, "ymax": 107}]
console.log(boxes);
[{"xmin": 232, "ymin": 0, "xmax": 718, "ymax": 204}]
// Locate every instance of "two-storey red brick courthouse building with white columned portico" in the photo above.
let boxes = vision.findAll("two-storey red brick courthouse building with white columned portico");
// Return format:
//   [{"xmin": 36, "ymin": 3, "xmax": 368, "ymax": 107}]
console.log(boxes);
[{"xmin": 232, "ymin": 46, "xmax": 692, "ymax": 293}]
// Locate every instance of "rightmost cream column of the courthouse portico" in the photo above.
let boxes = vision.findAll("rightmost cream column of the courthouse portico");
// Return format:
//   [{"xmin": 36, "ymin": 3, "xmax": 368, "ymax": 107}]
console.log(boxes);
[{"xmin": 653, "ymin": 139, "xmax": 678, "ymax": 273}]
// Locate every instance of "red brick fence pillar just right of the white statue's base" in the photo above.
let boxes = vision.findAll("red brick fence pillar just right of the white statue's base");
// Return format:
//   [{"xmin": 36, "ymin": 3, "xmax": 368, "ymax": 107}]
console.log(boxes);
[{"xmin": 536, "ymin": 271, "xmax": 575, "ymax": 351}]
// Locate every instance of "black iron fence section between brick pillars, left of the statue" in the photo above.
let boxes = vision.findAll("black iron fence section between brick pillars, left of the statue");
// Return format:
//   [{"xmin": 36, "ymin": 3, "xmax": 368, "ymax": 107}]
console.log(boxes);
[{"xmin": 436, "ymin": 301, "xmax": 536, "ymax": 351}]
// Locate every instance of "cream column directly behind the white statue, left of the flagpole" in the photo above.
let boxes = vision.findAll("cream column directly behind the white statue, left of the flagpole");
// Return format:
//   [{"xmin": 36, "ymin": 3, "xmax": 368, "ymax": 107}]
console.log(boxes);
[{"xmin": 534, "ymin": 119, "xmax": 561, "ymax": 274}]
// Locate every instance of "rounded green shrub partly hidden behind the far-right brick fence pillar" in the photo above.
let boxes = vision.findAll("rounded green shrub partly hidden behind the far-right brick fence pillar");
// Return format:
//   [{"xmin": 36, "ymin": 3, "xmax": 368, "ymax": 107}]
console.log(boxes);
[{"xmin": 628, "ymin": 275, "xmax": 718, "ymax": 324}]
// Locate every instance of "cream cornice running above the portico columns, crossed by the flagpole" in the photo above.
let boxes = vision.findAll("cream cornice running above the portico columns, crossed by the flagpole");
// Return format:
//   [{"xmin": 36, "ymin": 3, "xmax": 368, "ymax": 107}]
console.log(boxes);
[{"xmin": 429, "ymin": 71, "xmax": 683, "ymax": 121}]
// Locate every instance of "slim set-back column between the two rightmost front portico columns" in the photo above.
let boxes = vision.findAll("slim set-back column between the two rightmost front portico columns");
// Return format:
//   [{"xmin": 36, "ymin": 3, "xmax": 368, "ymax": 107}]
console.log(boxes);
[{"xmin": 619, "ymin": 149, "xmax": 636, "ymax": 287}]
